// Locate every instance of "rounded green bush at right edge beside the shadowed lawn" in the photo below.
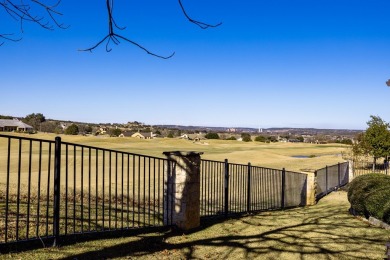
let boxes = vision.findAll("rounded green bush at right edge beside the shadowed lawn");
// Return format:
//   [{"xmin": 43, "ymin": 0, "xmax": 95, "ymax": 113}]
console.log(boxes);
[{"xmin": 348, "ymin": 173, "xmax": 390, "ymax": 223}]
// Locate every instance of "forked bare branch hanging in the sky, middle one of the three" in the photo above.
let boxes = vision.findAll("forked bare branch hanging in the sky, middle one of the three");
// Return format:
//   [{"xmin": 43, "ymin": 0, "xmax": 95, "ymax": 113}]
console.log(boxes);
[{"xmin": 79, "ymin": 0, "xmax": 175, "ymax": 59}]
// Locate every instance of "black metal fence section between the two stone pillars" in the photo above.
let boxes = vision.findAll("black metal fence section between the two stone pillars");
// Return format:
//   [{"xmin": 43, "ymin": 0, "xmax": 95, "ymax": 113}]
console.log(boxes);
[{"xmin": 201, "ymin": 160, "xmax": 307, "ymax": 217}]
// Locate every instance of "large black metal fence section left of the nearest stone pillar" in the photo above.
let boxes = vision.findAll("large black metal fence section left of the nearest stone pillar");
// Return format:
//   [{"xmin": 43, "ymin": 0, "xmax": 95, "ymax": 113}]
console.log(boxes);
[{"xmin": 0, "ymin": 135, "xmax": 166, "ymax": 248}]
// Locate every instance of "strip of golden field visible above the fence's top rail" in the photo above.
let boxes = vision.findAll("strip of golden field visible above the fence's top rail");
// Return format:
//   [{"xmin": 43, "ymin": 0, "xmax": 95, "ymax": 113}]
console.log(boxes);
[{"xmin": 0, "ymin": 134, "xmax": 348, "ymax": 172}]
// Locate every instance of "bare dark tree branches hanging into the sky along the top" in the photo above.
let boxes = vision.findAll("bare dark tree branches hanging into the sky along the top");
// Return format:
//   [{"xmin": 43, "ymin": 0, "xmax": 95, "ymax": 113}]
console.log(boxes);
[{"xmin": 0, "ymin": 0, "xmax": 222, "ymax": 59}]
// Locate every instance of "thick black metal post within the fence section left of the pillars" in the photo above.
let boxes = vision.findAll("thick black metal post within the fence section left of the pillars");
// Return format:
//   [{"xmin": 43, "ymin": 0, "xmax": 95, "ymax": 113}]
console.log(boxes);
[{"xmin": 53, "ymin": 136, "xmax": 61, "ymax": 246}]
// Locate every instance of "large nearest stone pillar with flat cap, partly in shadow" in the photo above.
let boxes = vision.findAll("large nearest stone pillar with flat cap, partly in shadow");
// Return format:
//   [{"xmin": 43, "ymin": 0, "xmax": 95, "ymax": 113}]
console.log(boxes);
[{"xmin": 164, "ymin": 151, "xmax": 201, "ymax": 230}]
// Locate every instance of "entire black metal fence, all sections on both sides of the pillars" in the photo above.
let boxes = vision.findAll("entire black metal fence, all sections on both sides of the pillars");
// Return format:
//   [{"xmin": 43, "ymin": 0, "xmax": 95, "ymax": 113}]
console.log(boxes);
[{"xmin": 0, "ymin": 134, "xmax": 348, "ymax": 248}]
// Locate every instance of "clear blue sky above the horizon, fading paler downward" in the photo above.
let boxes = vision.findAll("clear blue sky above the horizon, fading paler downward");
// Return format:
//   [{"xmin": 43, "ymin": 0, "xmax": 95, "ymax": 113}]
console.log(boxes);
[{"xmin": 0, "ymin": 0, "xmax": 390, "ymax": 129}]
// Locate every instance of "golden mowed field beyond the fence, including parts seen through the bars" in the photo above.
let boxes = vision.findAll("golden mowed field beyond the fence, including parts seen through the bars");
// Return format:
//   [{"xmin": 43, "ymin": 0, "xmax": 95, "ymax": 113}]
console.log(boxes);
[{"xmin": 0, "ymin": 134, "xmax": 347, "ymax": 246}]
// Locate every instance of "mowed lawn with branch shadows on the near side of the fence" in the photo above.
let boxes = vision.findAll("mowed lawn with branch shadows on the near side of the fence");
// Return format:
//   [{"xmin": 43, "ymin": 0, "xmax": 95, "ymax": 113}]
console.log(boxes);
[{"xmin": 0, "ymin": 191, "xmax": 390, "ymax": 260}]
